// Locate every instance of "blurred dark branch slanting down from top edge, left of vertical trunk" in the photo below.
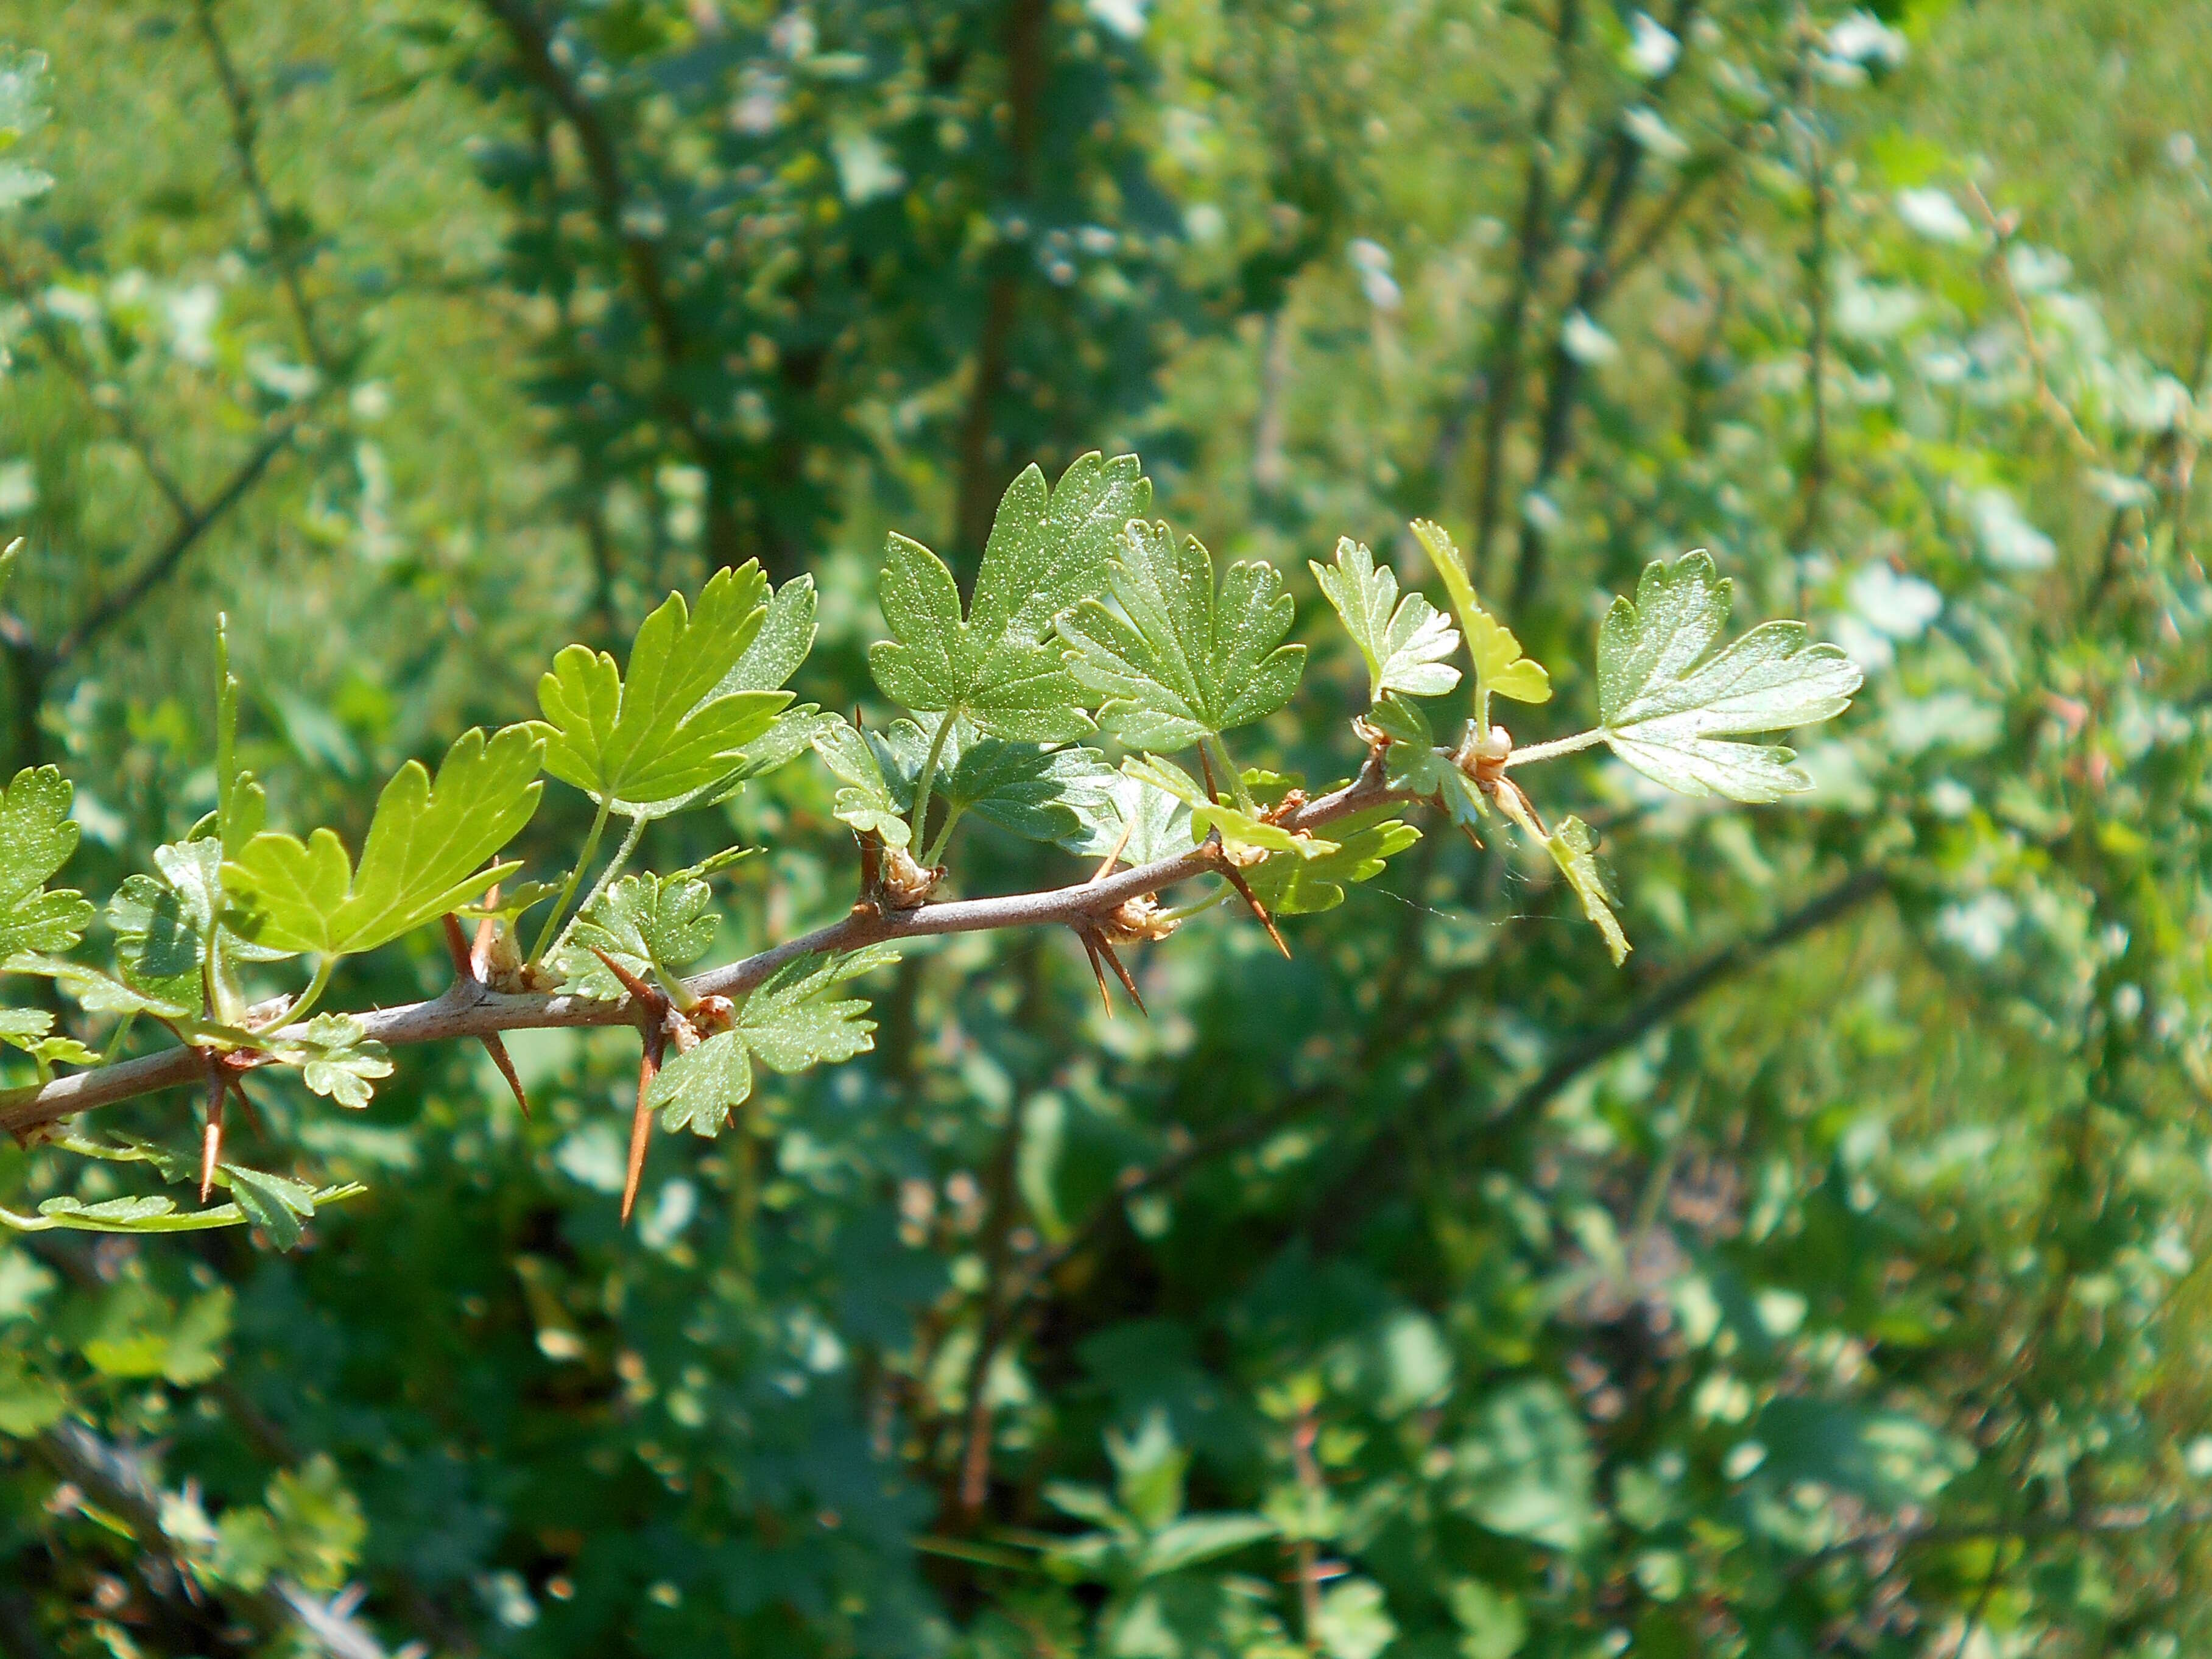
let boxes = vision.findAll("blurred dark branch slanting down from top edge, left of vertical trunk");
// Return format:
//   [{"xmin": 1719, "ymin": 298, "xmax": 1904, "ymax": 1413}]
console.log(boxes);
[{"xmin": 484, "ymin": 0, "xmax": 752, "ymax": 575}]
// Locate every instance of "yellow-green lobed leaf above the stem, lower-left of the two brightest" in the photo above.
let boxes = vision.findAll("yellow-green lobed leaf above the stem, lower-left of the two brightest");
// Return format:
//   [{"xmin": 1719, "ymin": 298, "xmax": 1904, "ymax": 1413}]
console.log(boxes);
[{"xmin": 221, "ymin": 725, "xmax": 544, "ymax": 956}]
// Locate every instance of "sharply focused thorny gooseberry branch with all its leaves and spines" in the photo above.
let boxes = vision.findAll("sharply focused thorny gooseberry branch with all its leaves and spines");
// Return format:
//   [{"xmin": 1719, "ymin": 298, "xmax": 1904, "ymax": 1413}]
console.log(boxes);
[{"xmin": 0, "ymin": 454, "xmax": 1861, "ymax": 1247}]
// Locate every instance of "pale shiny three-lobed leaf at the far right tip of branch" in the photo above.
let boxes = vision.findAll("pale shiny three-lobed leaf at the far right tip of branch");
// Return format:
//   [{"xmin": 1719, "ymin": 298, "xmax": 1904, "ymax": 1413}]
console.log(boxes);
[{"xmin": 1597, "ymin": 549, "xmax": 1861, "ymax": 803}]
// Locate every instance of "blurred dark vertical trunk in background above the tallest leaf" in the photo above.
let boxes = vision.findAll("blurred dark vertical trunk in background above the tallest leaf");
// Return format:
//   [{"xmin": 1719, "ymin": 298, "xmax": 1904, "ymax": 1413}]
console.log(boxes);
[{"xmin": 953, "ymin": 0, "xmax": 1051, "ymax": 568}]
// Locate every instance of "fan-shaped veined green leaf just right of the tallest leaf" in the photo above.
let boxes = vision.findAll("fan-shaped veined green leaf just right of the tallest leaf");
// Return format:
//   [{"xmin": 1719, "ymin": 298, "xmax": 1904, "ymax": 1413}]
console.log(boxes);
[{"xmin": 1060, "ymin": 520, "xmax": 1305, "ymax": 752}]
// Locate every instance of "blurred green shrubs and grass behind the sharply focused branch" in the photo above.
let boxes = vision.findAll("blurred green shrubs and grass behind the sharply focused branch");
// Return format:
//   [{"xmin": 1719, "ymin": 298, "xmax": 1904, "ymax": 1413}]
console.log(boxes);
[{"xmin": 0, "ymin": 0, "xmax": 2212, "ymax": 1659}]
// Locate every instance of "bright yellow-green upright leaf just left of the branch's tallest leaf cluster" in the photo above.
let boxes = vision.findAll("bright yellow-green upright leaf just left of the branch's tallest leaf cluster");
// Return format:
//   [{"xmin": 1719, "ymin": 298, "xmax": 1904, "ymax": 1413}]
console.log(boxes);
[{"xmin": 538, "ymin": 560, "xmax": 812, "ymax": 819}]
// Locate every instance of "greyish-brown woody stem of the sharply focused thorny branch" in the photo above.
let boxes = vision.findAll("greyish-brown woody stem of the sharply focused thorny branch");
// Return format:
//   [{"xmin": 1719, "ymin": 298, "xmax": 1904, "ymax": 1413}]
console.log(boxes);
[{"xmin": 0, "ymin": 759, "xmax": 1404, "ymax": 1135}]
